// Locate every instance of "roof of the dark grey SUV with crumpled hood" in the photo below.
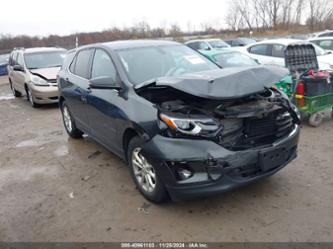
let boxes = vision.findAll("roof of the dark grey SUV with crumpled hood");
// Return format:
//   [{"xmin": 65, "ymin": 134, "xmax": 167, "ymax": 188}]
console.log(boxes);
[{"xmin": 100, "ymin": 40, "xmax": 180, "ymax": 50}]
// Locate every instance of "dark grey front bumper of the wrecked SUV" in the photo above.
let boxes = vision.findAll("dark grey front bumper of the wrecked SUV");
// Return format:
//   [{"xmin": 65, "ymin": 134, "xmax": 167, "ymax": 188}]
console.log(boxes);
[{"xmin": 142, "ymin": 125, "xmax": 300, "ymax": 200}]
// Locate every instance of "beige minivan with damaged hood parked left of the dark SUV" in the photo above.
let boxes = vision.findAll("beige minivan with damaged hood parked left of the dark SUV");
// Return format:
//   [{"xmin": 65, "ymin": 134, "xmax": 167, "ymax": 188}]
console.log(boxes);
[{"xmin": 8, "ymin": 48, "xmax": 66, "ymax": 107}]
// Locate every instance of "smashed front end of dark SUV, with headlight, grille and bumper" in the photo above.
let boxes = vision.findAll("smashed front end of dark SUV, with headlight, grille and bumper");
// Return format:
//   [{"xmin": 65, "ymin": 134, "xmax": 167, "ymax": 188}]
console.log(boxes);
[{"xmin": 137, "ymin": 65, "xmax": 300, "ymax": 199}]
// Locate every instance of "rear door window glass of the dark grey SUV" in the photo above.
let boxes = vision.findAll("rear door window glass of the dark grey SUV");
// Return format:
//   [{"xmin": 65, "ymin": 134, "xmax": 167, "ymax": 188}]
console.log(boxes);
[{"xmin": 70, "ymin": 49, "xmax": 93, "ymax": 79}]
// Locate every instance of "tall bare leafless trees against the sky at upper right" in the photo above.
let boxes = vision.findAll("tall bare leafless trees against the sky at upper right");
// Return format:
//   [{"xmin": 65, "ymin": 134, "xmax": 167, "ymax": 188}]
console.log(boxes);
[{"xmin": 225, "ymin": 0, "xmax": 333, "ymax": 32}]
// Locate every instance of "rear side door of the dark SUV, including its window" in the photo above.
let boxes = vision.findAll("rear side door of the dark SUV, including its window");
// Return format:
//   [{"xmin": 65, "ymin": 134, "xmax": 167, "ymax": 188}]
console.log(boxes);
[{"xmin": 64, "ymin": 48, "xmax": 94, "ymax": 131}]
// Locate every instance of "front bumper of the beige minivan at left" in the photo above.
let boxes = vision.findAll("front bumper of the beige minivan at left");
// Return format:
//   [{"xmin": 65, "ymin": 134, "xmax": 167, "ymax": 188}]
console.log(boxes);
[{"xmin": 29, "ymin": 84, "xmax": 59, "ymax": 104}]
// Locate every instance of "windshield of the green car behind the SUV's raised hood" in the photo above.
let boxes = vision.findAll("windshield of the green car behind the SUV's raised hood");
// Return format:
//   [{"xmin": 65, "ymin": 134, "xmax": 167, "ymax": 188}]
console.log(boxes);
[{"xmin": 214, "ymin": 52, "xmax": 258, "ymax": 67}]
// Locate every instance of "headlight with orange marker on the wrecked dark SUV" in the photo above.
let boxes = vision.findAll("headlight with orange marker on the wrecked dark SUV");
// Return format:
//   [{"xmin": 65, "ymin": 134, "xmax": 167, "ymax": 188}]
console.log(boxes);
[{"xmin": 160, "ymin": 114, "xmax": 222, "ymax": 136}]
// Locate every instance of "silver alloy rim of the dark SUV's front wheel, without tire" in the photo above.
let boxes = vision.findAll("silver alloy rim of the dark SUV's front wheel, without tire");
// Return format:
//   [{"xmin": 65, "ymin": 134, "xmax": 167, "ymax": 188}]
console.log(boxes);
[{"xmin": 132, "ymin": 147, "xmax": 156, "ymax": 193}]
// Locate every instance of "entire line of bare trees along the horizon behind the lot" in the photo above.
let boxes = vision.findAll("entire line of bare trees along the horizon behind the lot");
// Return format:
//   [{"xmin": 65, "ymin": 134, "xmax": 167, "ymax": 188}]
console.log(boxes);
[{"xmin": 0, "ymin": 0, "xmax": 333, "ymax": 51}]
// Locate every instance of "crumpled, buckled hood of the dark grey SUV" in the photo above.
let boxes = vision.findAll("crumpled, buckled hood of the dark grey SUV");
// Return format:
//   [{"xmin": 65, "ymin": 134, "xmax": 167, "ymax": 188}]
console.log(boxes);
[{"xmin": 135, "ymin": 65, "xmax": 289, "ymax": 99}]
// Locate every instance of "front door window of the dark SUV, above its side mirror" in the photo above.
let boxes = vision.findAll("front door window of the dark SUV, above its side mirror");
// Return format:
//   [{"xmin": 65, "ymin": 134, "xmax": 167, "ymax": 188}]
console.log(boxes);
[{"xmin": 91, "ymin": 49, "xmax": 117, "ymax": 82}]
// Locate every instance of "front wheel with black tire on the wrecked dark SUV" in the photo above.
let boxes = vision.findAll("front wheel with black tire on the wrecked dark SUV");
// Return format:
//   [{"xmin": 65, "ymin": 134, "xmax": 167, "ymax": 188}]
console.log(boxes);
[{"xmin": 127, "ymin": 136, "xmax": 168, "ymax": 203}]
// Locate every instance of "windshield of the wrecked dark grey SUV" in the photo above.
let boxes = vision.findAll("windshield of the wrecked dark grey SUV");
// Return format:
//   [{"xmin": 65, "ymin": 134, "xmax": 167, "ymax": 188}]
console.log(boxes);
[{"xmin": 116, "ymin": 45, "xmax": 219, "ymax": 84}]
